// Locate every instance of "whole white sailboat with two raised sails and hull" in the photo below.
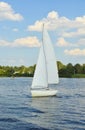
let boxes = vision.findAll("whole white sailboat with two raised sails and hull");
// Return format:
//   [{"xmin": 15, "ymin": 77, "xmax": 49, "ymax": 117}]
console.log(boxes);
[{"xmin": 31, "ymin": 25, "xmax": 59, "ymax": 97}]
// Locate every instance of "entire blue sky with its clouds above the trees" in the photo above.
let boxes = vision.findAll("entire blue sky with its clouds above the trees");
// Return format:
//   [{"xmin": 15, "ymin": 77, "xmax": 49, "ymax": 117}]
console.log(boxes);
[{"xmin": 0, "ymin": 0, "xmax": 85, "ymax": 66}]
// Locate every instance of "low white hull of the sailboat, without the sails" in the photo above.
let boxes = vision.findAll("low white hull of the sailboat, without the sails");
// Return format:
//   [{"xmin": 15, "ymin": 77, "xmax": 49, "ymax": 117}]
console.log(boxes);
[{"xmin": 31, "ymin": 89, "xmax": 57, "ymax": 97}]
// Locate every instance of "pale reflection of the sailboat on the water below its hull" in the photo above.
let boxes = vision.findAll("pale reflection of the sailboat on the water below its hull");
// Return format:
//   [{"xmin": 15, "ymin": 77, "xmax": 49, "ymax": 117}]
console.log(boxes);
[{"xmin": 31, "ymin": 97, "xmax": 58, "ymax": 129}]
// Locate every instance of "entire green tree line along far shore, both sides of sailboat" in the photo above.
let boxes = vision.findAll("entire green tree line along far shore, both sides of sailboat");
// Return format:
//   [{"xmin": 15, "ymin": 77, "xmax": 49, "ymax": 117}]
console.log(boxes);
[{"xmin": 0, "ymin": 61, "xmax": 85, "ymax": 78}]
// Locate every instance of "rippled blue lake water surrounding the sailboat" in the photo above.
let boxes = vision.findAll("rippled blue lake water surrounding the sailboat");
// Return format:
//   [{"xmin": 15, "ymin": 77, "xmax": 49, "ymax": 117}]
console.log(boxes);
[{"xmin": 0, "ymin": 78, "xmax": 85, "ymax": 130}]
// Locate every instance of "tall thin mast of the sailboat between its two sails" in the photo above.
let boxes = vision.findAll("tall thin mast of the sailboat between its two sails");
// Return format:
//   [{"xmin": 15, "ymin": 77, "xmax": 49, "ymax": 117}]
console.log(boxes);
[{"xmin": 42, "ymin": 23, "xmax": 48, "ymax": 88}]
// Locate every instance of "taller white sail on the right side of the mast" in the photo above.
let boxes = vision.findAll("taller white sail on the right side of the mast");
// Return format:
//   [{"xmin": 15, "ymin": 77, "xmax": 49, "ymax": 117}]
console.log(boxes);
[{"xmin": 43, "ymin": 30, "xmax": 59, "ymax": 84}]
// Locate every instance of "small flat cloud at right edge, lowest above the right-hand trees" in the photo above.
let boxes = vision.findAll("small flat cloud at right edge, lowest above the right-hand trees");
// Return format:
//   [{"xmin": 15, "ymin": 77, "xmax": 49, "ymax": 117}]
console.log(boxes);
[{"xmin": 64, "ymin": 48, "xmax": 85, "ymax": 56}]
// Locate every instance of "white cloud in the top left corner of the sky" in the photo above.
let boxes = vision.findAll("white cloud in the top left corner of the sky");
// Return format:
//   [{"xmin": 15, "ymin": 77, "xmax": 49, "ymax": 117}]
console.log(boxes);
[{"xmin": 0, "ymin": 2, "xmax": 23, "ymax": 21}]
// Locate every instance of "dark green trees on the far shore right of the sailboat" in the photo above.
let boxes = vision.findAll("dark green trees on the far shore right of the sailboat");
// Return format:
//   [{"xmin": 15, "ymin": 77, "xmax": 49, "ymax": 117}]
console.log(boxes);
[{"xmin": 57, "ymin": 61, "xmax": 85, "ymax": 78}]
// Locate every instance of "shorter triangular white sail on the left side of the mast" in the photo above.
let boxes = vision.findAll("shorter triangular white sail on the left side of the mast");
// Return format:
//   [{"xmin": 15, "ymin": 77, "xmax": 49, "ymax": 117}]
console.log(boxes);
[{"xmin": 31, "ymin": 46, "xmax": 48, "ymax": 89}]
